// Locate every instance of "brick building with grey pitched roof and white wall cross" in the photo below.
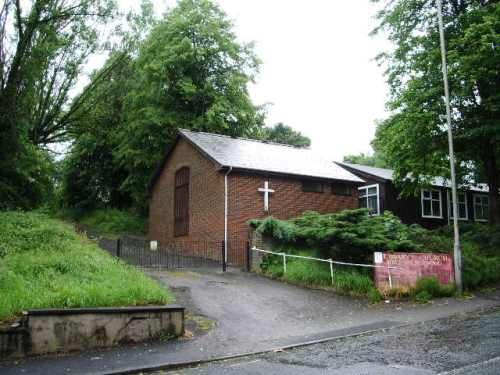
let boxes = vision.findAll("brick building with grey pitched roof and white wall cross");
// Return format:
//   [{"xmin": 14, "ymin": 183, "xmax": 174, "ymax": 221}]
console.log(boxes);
[{"xmin": 149, "ymin": 130, "xmax": 363, "ymax": 261}]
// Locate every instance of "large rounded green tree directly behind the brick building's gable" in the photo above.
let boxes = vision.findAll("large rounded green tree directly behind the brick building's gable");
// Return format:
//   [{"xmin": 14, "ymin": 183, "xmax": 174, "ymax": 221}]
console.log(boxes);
[{"xmin": 116, "ymin": 0, "xmax": 263, "ymax": 207}]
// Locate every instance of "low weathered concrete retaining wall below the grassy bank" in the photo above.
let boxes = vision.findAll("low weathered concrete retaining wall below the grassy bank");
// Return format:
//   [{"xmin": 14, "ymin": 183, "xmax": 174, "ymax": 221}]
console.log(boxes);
[{"xmin": 0, "ymin": 305, "xmax": 184, "ymax": 358}]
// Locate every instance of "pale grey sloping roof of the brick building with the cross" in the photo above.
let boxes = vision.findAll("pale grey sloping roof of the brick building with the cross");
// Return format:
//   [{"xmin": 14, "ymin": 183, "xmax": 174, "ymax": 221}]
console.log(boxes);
[{"xmin": 179, "ymin": 129, "xmax": 363, "ymax": 183}]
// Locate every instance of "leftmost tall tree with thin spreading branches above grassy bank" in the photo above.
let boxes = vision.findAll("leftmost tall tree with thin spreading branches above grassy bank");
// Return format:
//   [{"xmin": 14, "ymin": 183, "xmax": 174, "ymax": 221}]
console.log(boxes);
[{"xmin": 0, "ymin": 0, "xmax": 114, "ymax": 208}]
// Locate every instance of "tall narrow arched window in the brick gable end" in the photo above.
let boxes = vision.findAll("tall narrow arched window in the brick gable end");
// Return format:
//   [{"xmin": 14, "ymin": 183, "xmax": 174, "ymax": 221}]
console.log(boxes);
[{"xmin": 174, "ymin": 167, "xmax": 189, "ymax": 236}]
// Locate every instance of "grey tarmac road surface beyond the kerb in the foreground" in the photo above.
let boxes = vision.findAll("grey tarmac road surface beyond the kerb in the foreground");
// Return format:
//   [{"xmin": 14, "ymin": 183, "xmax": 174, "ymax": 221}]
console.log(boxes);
[{"xmin": 161, "ymin": 309, "xmax": 500, "ymax": 375}]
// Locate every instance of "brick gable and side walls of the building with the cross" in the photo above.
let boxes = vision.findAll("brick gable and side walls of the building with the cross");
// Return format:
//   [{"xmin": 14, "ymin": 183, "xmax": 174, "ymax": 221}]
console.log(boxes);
[{"xmin": 149, "ymin": 138, "xmax": 358, "ymax": 264}]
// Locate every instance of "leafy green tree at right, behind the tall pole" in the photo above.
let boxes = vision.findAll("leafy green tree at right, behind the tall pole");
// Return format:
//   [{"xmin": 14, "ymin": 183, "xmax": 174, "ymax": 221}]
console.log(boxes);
[{"xmin": 373, "ymin": 0, "xmax": 500, "ymax": 222}]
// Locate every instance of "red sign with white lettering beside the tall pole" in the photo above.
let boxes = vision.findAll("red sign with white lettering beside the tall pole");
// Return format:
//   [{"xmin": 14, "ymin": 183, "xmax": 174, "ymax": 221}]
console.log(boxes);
[{"xmin": 375, "ymin": 252, "xmax": 455, "ymax": 289}]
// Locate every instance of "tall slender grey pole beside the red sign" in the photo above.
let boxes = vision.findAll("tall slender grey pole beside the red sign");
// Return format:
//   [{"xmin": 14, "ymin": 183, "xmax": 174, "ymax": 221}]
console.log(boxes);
[{"xmin": 437, "ymin": 0, "xmax": 463, "ymax": 293}]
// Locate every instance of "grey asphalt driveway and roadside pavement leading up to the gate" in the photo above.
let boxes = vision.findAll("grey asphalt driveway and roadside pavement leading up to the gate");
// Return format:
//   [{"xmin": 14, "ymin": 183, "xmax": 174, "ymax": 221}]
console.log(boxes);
[{"xmin": 0, "ymin": 269, "xmax": 500, "ymax": 375}]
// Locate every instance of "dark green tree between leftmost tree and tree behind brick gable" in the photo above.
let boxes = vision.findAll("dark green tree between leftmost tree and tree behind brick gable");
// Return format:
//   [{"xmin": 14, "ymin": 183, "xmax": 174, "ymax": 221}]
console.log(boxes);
[{"xmin": 59, "ymin": 1, "xmax": 155, "ymax": 212}]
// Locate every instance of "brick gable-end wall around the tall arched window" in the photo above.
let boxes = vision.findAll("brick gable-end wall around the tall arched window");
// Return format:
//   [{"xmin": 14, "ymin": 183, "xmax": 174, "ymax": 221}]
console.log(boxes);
[{"xmin": 149, "ymin": 138, "xmax": 224, "ymax": 244}]
